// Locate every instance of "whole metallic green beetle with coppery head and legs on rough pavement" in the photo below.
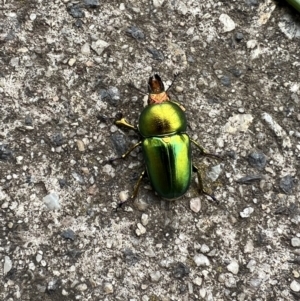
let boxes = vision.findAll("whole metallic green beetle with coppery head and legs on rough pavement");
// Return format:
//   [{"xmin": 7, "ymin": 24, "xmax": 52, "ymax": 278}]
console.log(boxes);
[{"xmin": 115, "ymin": 74, "xmax": 220, "ymax": 205}]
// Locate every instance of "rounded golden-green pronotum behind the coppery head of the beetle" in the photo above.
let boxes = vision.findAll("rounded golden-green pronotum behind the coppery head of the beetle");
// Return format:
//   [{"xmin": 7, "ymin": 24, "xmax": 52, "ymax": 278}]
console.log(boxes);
[{"xmin": 139, "ymin": 101, "xmax": 187, "ymax": 137}]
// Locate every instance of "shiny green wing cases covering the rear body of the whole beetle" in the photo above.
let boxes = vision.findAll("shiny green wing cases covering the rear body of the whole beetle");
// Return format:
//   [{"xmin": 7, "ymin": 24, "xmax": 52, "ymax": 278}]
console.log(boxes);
[{"xmin": 142, "ymin": 134, "xmax": 192, "ymax": 199}]
